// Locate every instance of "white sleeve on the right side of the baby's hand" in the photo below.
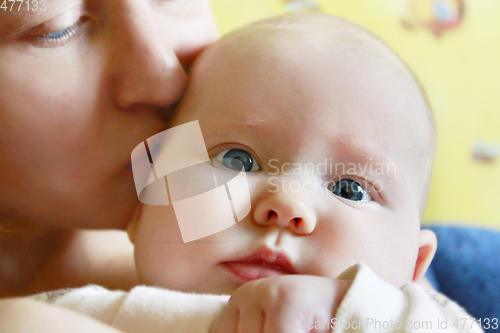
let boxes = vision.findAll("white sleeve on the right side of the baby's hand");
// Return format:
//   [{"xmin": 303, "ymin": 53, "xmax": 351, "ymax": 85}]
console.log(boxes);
[{"xmin": 332, "ymin": 263, "xmax": 483, "ymax": 333}]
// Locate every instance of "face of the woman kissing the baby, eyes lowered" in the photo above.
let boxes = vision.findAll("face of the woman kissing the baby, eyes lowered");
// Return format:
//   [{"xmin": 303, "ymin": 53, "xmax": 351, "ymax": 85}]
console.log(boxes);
[{"xmin": 0, "ymin": 0, "xmax": 217, "ymax": 228}]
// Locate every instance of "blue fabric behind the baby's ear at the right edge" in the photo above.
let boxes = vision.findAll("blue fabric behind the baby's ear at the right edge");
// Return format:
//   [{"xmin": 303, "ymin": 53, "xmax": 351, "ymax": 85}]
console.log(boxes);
[{"xmin": 422, "ymin": 226, "xmax": 500, "ymax": 326}]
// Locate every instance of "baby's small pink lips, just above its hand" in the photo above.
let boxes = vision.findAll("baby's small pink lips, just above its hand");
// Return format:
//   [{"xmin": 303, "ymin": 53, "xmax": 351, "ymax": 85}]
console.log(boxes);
[{"xmin": 223, "ymin": 250, "xmax": 297, "ymax": 283}]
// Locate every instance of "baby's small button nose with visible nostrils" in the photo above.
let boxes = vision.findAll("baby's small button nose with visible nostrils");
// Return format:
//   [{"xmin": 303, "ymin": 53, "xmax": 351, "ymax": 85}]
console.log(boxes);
[{"xmin": 253, "ymin": 191, "xmax": 316, "ymax": 235}]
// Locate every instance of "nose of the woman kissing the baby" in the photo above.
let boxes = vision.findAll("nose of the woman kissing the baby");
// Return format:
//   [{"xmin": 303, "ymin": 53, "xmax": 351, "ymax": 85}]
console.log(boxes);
[{"xmin": 110, "ymin": 1, "xmax": 212, "ymax": 108}]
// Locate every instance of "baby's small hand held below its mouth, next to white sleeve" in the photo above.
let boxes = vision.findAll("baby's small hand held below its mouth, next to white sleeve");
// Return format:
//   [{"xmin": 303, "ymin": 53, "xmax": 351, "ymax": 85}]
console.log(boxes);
[{"xmin": 210, "ymin": 275, "xmax": 351, "ymax": 333}]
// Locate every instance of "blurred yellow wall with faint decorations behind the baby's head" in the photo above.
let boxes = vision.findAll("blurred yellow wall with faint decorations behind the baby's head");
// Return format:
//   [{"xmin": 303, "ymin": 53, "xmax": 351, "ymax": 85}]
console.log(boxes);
[{"xmin": 211, "ymin": 0, "xmax": 500, "ymax": 229}]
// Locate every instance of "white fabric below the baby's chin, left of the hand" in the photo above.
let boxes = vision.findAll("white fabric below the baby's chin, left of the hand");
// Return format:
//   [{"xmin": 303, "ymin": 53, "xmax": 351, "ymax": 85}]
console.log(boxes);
[{"xmin": 48, "ymin": 286, "xmax": 229, "ymax": 333}]
